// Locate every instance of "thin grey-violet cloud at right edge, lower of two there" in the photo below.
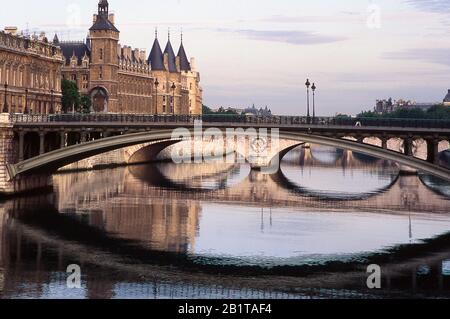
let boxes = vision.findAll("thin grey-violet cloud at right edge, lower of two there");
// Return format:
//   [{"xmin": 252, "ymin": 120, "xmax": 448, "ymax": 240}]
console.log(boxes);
[{"xmin": 383, "ymin": 48, "xmax": 450, "ymax": 66}]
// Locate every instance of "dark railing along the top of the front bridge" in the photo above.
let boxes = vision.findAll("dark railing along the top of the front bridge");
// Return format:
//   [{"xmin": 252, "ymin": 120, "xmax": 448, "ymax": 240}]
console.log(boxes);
[{"xmin": 9, "ymin": 114, "xmax": 450, "ymax": 129}]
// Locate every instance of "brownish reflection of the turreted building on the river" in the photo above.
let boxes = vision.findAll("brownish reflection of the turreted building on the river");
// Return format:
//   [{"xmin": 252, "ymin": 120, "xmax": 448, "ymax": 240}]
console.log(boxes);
[{"xmin": 54, "ymin": 169, "xmax": 201, "ymax": 252}]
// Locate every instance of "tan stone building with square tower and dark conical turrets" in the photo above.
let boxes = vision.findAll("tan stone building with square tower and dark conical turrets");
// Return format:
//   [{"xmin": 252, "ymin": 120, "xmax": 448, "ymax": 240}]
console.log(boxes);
[{"xmin": 58, "ymin": 0, "xmax": 202, "ymax": 114}]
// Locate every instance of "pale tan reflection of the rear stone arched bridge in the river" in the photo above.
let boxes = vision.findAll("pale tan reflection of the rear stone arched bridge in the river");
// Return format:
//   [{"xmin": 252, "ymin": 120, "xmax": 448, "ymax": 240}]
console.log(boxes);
[{"xmin": 55, "ymin": 158, "xmax": 449, "ymax": 213}]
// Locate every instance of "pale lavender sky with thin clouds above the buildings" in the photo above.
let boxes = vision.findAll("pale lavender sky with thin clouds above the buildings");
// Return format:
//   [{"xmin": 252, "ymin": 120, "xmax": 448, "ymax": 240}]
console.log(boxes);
[{"xmin": 0, "ymin": 0, "xmax": 450, "ymax": 115}]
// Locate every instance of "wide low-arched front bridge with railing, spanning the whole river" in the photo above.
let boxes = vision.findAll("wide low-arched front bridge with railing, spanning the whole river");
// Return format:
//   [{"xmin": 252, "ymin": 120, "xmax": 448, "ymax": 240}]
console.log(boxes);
[{"xmin": 0, "ymin": 114, "xmax": 450, "ymax": 193}]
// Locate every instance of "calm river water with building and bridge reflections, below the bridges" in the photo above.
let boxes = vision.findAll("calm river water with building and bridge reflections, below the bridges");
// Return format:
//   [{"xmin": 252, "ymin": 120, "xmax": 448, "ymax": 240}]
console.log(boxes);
[{"xmin": 0, "ymin": 147, "xmax": 450, "ymax": 299}]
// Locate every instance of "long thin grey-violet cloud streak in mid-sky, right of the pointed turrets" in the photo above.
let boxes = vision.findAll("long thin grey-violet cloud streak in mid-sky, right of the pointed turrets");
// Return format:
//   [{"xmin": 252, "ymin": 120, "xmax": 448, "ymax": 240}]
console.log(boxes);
[{"xmin": 219, "ymin": 29, "xmax": 346, "ymax": 45}]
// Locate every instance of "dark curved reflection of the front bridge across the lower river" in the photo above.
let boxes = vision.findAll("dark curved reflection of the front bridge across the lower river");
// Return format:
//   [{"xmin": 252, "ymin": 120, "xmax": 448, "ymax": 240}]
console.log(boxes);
[{"xmin": 0, "ymin": 192, "xmax": 450, "ymax": 299}]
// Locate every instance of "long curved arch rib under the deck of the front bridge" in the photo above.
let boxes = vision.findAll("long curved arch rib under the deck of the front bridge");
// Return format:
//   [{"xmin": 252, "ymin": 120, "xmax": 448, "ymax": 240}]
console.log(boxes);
[{"xmin": 7, "ymin": 130, "xmax": 450, "ymax": 181}]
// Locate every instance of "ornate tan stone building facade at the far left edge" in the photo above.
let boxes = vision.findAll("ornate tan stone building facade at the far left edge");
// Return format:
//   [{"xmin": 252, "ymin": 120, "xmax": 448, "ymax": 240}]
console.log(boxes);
[{"xmin": 0, "ymin": 28, "xmax": 64, "ymax": 114}]
